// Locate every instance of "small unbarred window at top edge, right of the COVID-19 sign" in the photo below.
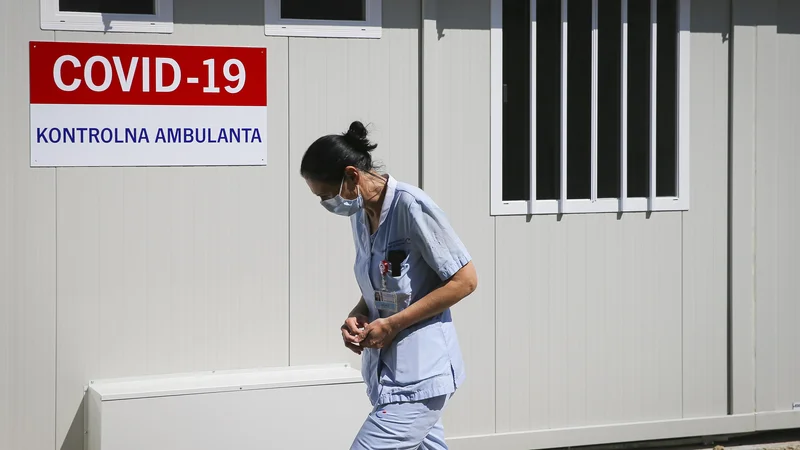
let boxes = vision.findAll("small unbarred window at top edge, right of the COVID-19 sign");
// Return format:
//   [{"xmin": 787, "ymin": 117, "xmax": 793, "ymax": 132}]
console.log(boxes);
[{"xmin": 264, "ymin": 0, "xmax": 381, "ymax": 38}]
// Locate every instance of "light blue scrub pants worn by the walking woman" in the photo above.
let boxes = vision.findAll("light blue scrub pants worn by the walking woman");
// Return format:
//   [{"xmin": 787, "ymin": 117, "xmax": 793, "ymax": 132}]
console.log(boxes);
[{"xmin": 350, "ymin": 394, "xmax": 450, "ymax": 450}]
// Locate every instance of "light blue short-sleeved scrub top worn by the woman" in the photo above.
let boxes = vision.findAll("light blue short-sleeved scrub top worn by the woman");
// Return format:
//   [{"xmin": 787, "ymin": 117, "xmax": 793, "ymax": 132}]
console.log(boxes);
[{"xmin": 351, "ymin": 176, "xmax": 472, "ymax": 406}]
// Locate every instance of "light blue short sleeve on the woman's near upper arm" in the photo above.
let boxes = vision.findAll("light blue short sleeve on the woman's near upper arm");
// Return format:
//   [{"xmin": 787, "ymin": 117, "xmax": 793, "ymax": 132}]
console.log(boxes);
[{"xmin": 408, "ymin": 197, "xmax": 472, "ymax": 281}]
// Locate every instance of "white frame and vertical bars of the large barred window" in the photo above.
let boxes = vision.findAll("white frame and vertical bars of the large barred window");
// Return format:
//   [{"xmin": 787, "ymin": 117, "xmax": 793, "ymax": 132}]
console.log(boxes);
[{"xmin": 490, "ymin": 0, "xmax": 691, "ymax": 216}]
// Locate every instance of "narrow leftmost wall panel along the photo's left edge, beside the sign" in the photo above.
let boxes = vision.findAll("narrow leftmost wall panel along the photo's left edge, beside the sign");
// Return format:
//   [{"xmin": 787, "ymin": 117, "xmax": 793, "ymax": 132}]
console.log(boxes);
[{"xmin": 0, "ymin": 0, "xmax": 56, "ymax": 450}]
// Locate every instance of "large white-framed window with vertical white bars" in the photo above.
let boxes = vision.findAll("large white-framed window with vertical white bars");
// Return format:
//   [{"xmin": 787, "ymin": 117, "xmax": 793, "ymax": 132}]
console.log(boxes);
[{"xmin": 491, "ymin": 0, "xmax": 689, "ymax": 215}]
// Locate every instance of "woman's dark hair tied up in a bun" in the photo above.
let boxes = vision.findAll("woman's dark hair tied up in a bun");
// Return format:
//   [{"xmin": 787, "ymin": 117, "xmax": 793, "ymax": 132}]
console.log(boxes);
[{"xmin": 300, "ymin": 121, "xmax": 378, "ymax": 184}]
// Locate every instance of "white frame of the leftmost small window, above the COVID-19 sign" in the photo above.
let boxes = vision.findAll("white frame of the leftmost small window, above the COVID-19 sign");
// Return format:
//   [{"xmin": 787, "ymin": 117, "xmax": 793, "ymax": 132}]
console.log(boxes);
[{"xmin": 40, "ymin": 0, "xmax": 173, "ymax": 33}]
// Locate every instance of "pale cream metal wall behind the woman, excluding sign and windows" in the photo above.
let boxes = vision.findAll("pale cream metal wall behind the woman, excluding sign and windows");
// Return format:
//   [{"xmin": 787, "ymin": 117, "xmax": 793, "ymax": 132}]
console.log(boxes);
[{"xmin": 0, "ymin": 0, "xmax": 800, "ymax": 450}]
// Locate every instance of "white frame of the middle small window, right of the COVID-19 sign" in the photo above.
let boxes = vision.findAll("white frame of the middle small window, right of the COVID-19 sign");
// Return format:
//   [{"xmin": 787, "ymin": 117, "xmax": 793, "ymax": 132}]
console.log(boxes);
[{"xmin": 264, "ymin": 0, "xmax": 383, "ymax": 39}]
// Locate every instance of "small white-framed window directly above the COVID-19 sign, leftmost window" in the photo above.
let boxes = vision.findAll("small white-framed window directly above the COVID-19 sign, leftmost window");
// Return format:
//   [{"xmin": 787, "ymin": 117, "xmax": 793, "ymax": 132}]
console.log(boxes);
[{"xmin": 40, "ymin": 0, "xmax": 173, "ymax": 33}]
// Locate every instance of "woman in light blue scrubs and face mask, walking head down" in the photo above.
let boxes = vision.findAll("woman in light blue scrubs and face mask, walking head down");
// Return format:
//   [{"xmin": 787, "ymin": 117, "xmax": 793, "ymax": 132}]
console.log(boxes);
[{"xmin": 300, "ymin": 122, "xmax": 477, "ymax": 450}]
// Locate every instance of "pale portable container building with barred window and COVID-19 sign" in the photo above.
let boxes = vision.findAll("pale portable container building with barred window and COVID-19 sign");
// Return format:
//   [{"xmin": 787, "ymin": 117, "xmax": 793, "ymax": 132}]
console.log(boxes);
[{"xmin": 0, "ymin": 0, "xmax": 800, "ymax": 450}]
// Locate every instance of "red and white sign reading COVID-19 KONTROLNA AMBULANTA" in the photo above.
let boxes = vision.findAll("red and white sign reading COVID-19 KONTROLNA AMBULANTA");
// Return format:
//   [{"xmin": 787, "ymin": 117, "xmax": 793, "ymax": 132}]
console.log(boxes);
[{"xmin": 30, "ymin": 42, "xmax": 267, "ymax": 167}]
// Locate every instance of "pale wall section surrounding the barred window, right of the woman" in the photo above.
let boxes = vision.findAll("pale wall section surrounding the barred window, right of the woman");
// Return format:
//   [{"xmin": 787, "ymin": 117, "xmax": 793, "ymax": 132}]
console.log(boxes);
[{"xmin": 423, "ymin": 0, "xmax": 729, "ymax": 434}]
